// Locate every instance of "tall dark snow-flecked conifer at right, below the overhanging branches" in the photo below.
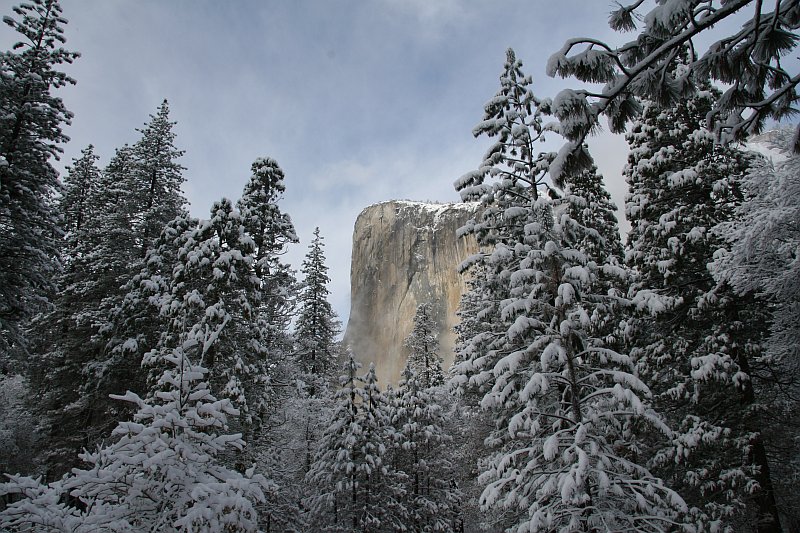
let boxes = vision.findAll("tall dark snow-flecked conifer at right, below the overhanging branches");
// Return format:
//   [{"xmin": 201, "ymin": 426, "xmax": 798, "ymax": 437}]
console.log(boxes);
[{"xmin": 624, "ymin": 83, "xmax": 780, "ymax": 532}]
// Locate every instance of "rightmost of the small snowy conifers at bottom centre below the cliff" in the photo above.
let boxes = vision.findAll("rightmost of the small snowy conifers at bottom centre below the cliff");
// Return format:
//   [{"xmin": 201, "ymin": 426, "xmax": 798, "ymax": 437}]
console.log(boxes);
[{"xmin": 392, "ymin": 361, "xmax": 462, "ymax": 532}]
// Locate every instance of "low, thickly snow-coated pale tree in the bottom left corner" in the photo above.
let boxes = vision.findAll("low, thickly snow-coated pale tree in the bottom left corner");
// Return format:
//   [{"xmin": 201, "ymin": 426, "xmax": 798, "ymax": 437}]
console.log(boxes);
[{"xmin": 0, "ymin": 348, "xmax": 269, "ymax": 533}]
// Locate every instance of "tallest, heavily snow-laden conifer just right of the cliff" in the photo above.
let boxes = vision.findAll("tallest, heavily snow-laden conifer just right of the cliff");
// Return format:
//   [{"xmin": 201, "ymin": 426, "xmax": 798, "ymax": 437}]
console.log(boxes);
[{"xmin": 454, "ymin": 50, "xmax": 690, "ymax": 532}]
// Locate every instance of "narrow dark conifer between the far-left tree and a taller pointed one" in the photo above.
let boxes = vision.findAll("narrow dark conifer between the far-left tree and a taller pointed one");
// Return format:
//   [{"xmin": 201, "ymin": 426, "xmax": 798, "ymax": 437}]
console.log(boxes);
[{"xmin": 29, "ymin": 146, "xmax": 115, "ymax": 478}]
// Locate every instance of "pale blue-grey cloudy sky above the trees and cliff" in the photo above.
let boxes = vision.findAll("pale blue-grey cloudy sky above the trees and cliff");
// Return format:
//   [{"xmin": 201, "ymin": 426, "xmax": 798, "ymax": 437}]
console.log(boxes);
[{"xmin": 0, "ymin": 0, "xmax": 626, "ymax": 320}]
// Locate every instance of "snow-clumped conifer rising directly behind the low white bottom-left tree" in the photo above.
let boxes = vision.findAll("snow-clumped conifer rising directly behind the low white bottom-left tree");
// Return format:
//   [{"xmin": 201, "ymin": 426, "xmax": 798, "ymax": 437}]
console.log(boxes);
[{"xmin": 137, "ymin": 199, "xmax": 270, "ymax": 448}]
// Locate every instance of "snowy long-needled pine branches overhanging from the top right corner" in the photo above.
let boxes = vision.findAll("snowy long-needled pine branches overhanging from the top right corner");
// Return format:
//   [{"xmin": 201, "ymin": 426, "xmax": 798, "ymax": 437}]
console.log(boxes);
[{"xmin": 547, "ymin": 0, "xmax": 800, "ymax": 177}]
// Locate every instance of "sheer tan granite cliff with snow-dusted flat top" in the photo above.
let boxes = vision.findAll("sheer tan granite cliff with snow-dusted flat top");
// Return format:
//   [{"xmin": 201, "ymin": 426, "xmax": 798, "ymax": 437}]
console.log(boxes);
[{"xmin": 344, "ymin": 201, "xmax": 478, "ymax": 384}]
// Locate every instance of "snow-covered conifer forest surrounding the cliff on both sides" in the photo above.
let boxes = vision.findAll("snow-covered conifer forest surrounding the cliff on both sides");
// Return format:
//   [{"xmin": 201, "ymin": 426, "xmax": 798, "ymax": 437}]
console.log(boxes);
[{"xmin": 0, "ymin": 0, "xmax": 800, "ymax": 533}]
